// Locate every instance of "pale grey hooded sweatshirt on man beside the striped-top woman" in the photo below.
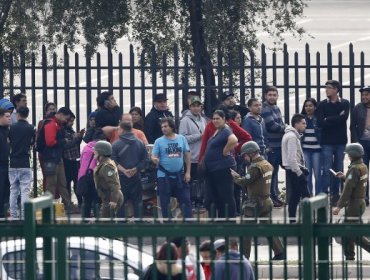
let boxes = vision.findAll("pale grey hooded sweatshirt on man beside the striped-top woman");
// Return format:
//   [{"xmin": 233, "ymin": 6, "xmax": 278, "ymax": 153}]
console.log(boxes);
[{"xmin": 281, "ymin": 125, "xmax": 305, "ymax": 176}]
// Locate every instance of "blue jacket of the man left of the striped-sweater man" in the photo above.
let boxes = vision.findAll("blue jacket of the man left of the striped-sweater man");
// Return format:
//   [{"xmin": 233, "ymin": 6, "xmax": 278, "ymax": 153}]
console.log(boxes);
[{"xmin": 243, "ymin": 113, "xmax": 268, "ymax": 154}]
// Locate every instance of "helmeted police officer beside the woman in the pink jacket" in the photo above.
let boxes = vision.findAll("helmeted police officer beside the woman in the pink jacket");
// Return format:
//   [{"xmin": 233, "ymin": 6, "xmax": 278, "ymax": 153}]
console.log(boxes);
[{"xmin": 94, "ymin": 141, "xmax": 123, "ymax": 218}]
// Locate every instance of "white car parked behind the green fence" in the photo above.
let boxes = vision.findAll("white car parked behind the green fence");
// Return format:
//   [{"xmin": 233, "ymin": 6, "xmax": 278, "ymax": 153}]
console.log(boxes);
[{"xmin": 0, "ymin": 237, "xmax": 153, "ymax": 280}]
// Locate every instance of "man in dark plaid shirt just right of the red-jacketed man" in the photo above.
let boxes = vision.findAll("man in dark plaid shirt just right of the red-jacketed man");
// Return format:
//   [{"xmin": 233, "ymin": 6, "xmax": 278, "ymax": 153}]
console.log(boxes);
[{"xmin": 63, "ymin": 114, "xmax": 85, "ymax": 207}]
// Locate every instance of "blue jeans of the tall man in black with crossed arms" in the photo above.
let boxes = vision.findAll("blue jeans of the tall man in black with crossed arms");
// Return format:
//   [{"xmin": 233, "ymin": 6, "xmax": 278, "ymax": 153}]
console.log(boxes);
[{"xmin": 320, "ymin": 145, "xmax": 346, "ymax": 195}]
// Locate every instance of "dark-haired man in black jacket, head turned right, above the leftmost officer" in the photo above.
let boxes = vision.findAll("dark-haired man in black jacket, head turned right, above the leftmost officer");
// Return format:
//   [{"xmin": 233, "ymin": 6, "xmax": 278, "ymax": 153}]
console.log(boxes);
[{"xmin": 95, "ymin": 91, "xmax": 122, "ymax": 128}]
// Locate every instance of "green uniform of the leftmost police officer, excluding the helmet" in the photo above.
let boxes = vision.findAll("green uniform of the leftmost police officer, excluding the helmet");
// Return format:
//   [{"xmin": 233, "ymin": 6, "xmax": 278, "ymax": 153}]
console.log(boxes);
[{"xmin": 94, "ymin": 157, "xmax": 123, "ymax": 218}]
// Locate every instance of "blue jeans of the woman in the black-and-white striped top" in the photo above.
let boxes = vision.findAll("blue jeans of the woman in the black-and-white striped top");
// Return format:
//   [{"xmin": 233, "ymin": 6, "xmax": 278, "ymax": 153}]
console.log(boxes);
[{"xmin": 303, "ymin": 149, "xmax": 321, "ymax": 195}]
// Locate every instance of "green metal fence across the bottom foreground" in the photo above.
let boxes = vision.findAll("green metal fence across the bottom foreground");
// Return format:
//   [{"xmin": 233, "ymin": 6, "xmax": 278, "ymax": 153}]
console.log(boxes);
[{"xmin": 0, "ymin": 195, "xmax": 370, "ymax": 280}]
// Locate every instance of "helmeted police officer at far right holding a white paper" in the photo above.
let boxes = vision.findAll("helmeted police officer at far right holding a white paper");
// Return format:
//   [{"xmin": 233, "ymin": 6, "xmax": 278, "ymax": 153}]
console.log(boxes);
[{"xmin": 332, "ymin": 143, "xmax": 370, "ymax": 260}]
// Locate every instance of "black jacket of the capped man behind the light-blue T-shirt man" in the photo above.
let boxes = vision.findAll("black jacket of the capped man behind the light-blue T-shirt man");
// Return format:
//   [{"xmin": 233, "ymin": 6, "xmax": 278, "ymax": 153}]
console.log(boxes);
[{"xmin": 144, "ymin": 107, "xmax": 173, "ymax": 144}]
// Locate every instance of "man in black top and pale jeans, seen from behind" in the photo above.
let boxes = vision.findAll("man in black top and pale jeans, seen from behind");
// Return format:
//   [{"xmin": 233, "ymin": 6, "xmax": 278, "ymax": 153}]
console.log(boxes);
[{"xmin": 9, "ymin": 107, "xmax": 36, "ymax": 218}]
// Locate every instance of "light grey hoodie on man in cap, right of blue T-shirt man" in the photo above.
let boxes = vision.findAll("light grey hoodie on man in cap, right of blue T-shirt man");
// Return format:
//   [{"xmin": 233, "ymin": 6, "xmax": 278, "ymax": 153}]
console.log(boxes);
[{"xmin": 179, "ymin": 110, "xmax": 207, "ymax": 163}]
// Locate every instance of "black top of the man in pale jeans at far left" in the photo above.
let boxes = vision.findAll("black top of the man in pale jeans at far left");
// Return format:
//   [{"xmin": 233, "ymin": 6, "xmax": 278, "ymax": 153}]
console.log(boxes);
[{"xmin": 9, "ymin": 120, "xmax": 36, "ymax": 168}]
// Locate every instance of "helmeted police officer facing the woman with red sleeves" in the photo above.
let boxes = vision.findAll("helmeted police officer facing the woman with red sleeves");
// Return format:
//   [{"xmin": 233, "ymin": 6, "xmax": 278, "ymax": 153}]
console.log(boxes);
[{"xmin": 232, "ymin": 141, "xmax": 285, "ymax": 260}]
